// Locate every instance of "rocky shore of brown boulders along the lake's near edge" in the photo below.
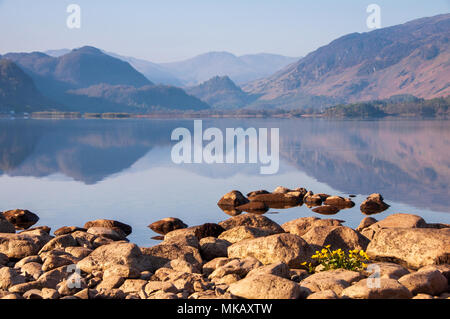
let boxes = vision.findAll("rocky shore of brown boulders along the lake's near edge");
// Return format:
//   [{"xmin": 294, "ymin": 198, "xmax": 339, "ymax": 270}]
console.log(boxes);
[{"xmin": 0, "ymin": 187, "xmax": 450, "ymax": 299}]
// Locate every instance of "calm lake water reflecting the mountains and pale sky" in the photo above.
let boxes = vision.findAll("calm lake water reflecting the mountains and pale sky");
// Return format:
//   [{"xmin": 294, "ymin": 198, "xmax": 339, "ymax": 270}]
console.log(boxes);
[{"xmin": 0, "ymin": 119, "xmax": 450, "ymax": 246}]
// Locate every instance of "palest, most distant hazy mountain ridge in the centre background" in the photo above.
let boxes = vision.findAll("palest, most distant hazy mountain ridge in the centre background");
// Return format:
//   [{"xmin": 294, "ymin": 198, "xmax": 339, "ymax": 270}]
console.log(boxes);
[{"xmin": 161, "ymin": 52, "xmax": 297, "ymax": 86}]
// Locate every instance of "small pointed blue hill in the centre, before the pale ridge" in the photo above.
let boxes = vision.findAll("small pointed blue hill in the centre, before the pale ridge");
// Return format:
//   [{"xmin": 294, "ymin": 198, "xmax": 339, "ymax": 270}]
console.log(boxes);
[{"xmin": 186, "ymin": 76, "xmax": 256, "ymax": 109}]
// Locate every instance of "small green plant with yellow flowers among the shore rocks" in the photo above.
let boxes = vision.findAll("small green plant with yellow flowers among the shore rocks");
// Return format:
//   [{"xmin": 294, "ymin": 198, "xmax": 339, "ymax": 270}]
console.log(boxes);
[{"xmin": 302, "ymin": 245, "xmax": 369, "ymax": 273}]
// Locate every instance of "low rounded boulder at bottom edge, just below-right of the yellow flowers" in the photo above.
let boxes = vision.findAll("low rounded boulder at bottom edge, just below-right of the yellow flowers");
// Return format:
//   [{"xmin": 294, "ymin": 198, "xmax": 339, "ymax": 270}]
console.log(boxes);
[{"xmin": 342, "ymin": 278, "xmax": 412, "ymax": 299}]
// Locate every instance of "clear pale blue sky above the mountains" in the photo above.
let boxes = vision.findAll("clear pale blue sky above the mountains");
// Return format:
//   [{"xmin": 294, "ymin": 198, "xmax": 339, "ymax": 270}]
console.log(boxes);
[{"xmin": 0, "ymin": 0, "xmax": 450, "ymax": 63}]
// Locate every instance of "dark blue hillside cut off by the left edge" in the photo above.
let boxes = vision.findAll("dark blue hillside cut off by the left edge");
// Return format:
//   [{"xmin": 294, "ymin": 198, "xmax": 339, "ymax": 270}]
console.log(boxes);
[{"xmin": 0, "ymin": 59, "xmax": 48, "ymax": 112}]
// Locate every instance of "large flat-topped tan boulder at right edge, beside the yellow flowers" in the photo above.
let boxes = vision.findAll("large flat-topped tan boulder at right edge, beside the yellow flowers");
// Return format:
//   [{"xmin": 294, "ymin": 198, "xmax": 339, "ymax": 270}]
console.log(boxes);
[{"xmin": 367, "ymin": 228, "xmax": 450, "ymax": 269}]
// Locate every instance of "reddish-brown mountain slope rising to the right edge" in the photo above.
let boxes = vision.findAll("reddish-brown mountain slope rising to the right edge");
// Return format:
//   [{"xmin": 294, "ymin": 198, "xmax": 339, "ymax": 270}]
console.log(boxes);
[{"xmin": 244, "ymin": 14, "xmax": 450, "ymax": 108}]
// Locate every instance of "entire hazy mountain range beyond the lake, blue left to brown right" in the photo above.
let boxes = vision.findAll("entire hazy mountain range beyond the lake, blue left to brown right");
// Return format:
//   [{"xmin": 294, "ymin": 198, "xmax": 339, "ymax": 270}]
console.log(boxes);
[{"xmin": 0, "ymin": 14, "xmax": 450, "ymax": 113}]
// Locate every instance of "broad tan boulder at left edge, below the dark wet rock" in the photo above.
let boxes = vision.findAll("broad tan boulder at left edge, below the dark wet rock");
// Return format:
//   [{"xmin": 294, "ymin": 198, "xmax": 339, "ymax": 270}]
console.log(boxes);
[{"xmin": 0, "ymin": 230, "xmax": 52, "ymax": 259}]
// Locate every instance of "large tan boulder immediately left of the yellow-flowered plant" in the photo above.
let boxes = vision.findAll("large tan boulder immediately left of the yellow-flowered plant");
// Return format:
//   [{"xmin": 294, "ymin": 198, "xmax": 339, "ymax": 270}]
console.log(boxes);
[{"xmin": 228, "ymin": 233, "xmax": 312, "ymax": 268}]
